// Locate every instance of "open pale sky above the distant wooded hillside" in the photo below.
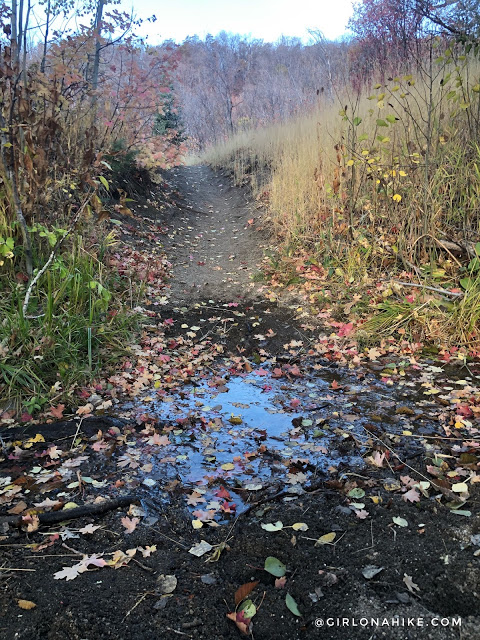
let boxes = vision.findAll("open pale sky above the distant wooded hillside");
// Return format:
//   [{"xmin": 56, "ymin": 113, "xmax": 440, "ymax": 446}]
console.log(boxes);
[{"xmin": 118, "ymin": 0, "xmax": 352, "ymax": 44}]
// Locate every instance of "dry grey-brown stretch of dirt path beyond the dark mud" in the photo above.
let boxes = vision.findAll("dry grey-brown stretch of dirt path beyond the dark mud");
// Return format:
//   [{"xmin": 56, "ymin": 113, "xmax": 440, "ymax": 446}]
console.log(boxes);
[{"xmin": 166, "ymin": 166, "xmax": 263, "ymax": 306}]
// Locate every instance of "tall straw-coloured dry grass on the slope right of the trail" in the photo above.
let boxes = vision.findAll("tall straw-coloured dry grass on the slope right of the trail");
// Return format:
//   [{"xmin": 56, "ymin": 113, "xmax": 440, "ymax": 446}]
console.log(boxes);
[{"xmin": 202, "ymin": 46, "xmax": 480, "ymax": 350}]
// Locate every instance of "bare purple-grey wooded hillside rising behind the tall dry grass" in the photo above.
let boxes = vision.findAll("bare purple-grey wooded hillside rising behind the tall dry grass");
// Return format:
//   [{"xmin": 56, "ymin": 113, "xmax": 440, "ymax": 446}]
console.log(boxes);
[{"xmin": 164, "ymin": 0, "xmax": 480, "ymax": 150}]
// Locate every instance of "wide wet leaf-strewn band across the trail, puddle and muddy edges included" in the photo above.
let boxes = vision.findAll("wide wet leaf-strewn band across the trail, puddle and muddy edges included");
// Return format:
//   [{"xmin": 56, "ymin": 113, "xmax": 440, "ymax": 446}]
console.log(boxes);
[{"xmin": 5, "ymin": 357, "xmax": 480, "ymax": 526}]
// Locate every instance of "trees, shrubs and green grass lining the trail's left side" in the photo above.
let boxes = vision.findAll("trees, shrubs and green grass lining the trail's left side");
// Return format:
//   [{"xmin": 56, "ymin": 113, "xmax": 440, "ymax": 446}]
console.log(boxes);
[{"xmin": 0, "ymin": 0, "xmax": 184, "ymax": 416}]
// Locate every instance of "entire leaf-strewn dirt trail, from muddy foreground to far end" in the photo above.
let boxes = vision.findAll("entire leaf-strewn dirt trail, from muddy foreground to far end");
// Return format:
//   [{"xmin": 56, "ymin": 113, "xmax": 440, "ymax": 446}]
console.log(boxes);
[{"xmin": 0, "ymin": 167, "xmax": 480, "ymax": 640}]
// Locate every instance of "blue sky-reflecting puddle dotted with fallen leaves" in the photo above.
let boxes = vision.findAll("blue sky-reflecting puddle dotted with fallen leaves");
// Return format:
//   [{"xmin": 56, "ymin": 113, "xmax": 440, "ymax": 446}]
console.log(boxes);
[{"xmin": 117, "ymin": 363, "xmax": 464, "ymax": 522}]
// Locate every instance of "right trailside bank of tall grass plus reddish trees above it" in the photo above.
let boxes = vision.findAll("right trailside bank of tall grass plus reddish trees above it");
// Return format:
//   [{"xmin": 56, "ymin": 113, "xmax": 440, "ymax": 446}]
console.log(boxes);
[{"xmin": 184, "ymin": 0, "xmax": 480, "ymax": 353}]
